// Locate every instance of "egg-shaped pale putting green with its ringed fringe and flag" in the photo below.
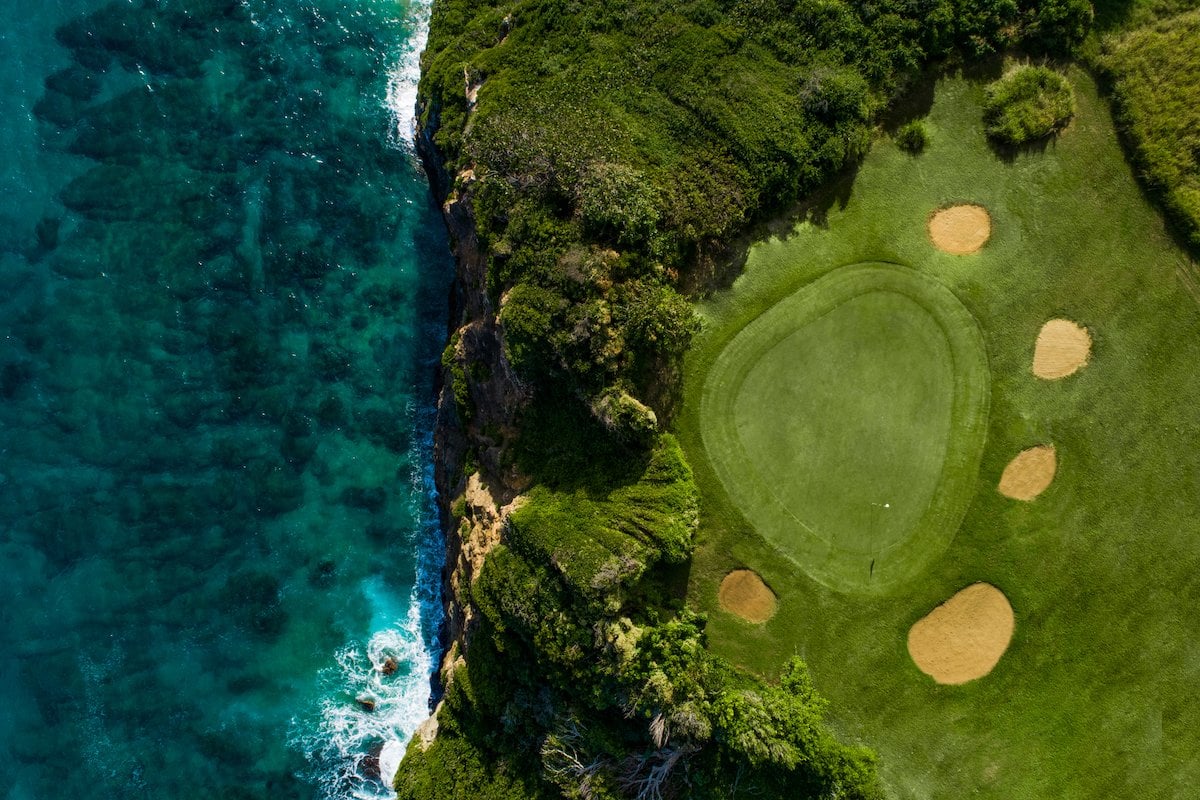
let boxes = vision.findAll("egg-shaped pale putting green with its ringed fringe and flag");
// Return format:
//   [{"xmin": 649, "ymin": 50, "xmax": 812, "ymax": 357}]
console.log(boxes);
[{"xmin": 700, "ymin": 264, "xmax": 990, "ymax": 593}]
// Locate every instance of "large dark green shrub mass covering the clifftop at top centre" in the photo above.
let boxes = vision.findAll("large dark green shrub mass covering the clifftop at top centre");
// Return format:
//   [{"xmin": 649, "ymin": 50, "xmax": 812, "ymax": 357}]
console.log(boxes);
[{"xmin": 421, "ymin": 0, "xmax": 1090, "ymax": 417}]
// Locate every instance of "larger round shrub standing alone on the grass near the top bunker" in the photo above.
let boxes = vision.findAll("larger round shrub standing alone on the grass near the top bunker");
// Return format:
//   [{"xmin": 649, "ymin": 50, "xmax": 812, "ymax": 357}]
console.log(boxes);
[{"xmin": 983, "ymin": 66, "xmax": 1075, "ymax": 145}]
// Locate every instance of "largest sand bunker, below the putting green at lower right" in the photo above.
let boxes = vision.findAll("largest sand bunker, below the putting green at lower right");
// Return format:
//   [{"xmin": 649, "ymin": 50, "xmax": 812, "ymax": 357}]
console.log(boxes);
[{"xmin": 908, "ymin": 583, "xmax": 1015, "ymax": 685}]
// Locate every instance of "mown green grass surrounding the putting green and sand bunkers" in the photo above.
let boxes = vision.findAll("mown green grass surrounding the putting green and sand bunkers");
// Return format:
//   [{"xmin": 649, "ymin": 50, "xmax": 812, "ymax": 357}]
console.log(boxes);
[{"xmin": 678, "ymin": 72, "xmax": 1200, "ymax": 800}]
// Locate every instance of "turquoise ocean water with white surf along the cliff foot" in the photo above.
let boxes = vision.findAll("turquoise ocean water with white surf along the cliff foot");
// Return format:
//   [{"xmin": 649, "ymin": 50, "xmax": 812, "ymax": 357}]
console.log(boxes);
[{"xmin": 0, "ymin": 0, "xmax": 451, "ymax": 800}]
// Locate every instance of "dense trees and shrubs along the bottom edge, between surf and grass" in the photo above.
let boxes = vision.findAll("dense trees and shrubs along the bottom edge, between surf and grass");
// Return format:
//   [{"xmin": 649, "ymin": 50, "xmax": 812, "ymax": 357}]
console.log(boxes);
[{"xmin": 396, "ymin": 534, "xmax": 881, "ymax": 800}]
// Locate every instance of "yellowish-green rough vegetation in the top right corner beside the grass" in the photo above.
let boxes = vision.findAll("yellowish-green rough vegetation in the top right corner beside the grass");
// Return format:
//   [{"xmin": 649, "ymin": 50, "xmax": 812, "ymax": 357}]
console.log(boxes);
[{"xmin": 1100, "ymin": 8, "xmax": 1200, "ymax": 251}]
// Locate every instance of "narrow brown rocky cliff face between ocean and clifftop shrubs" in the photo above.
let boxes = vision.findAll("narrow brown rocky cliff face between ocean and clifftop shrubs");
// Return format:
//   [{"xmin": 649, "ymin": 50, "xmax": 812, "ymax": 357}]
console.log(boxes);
[{"xmin": 418, "ymin": 114, "xmax": 527, "ymax": 682}]
